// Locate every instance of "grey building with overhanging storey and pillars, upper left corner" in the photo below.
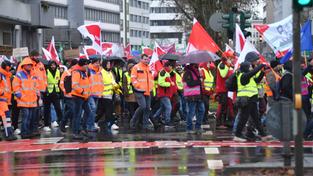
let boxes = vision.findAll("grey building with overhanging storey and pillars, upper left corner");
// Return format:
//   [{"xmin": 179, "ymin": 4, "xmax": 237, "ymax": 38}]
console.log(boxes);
[{"xmin": 0, "ymin": 0, "xmax": 53, "ymax": 55}]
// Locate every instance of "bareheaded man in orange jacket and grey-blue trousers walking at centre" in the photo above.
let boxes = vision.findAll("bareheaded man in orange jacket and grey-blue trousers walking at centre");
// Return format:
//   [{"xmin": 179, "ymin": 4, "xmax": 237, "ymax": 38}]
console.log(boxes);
[{"xmin": 130, "ymin": 54, "xmax": 154, "ymax": 131}]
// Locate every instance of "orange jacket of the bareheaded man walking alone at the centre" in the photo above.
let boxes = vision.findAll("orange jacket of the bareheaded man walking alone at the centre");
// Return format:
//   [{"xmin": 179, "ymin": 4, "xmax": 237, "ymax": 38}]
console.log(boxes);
[{"xmin": 130, "ymin": 62, "xmax": 154, "ymax": 96}]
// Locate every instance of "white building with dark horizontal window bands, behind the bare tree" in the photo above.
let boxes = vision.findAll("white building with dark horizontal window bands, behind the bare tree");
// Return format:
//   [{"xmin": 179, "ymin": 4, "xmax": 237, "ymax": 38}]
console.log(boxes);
[{"xmin": 150, "ymin": 0, "xmax": 186, "ymax": 50}]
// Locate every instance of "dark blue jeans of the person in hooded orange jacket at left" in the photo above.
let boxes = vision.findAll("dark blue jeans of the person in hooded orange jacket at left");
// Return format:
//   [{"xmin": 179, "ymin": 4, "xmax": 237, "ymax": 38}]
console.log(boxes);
[{"xmin": 20, "ymin": 107, "xmax": 37, "ymax": 135}]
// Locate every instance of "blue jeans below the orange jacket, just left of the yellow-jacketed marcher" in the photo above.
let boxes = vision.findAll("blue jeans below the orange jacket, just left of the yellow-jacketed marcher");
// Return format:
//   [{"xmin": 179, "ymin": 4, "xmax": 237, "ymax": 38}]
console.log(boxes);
[{"xmin": 83, "ymin": 97, "xmax": 98, "ymax": 131}]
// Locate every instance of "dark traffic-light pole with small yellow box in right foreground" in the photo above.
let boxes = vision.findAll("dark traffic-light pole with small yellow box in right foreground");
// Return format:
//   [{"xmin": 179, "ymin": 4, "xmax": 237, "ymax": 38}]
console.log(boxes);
[{"xmin": 293, "ymin": 1, "xmax": 303, "ymax": 176}]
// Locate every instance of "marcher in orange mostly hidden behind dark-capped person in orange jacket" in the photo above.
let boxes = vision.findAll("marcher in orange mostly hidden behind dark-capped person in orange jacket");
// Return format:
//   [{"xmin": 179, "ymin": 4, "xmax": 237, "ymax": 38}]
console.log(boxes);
[{"xmin": 60, "ymin": 59, "xmax": 78, "ymax": 133}]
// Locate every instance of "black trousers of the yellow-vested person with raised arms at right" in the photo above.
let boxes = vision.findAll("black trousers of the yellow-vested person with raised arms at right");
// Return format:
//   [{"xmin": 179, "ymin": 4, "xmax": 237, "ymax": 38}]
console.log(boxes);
[{"xmin": 235, "ymin": 101, "xmax": 266, "ymax": 137}]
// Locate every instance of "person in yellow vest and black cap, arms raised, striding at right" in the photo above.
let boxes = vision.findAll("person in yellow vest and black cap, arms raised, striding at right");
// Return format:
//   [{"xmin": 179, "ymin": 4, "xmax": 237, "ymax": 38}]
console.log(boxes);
[{"xmin": 234, "ymin": 57, "xmax": 272, "ymax": 142}]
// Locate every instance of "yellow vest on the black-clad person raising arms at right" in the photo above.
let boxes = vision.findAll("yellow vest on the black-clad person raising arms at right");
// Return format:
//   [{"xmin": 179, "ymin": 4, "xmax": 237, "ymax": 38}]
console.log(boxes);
[{"xmin": 237, "ymin": 73, "xmax": 258, "ymax": 97}]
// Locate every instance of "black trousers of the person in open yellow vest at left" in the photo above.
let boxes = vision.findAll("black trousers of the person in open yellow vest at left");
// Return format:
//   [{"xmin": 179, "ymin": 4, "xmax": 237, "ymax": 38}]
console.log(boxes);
[{"xmin": 43, "ymin": 93, "xmax": 63, "ymax": 126}]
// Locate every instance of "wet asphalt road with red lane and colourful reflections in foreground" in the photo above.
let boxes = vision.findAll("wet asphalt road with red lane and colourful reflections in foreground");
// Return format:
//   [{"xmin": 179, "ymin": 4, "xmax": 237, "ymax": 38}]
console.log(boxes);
[{"xmin": 0, "ymin": 121, "xmax": 313, "ymax": 176}]
